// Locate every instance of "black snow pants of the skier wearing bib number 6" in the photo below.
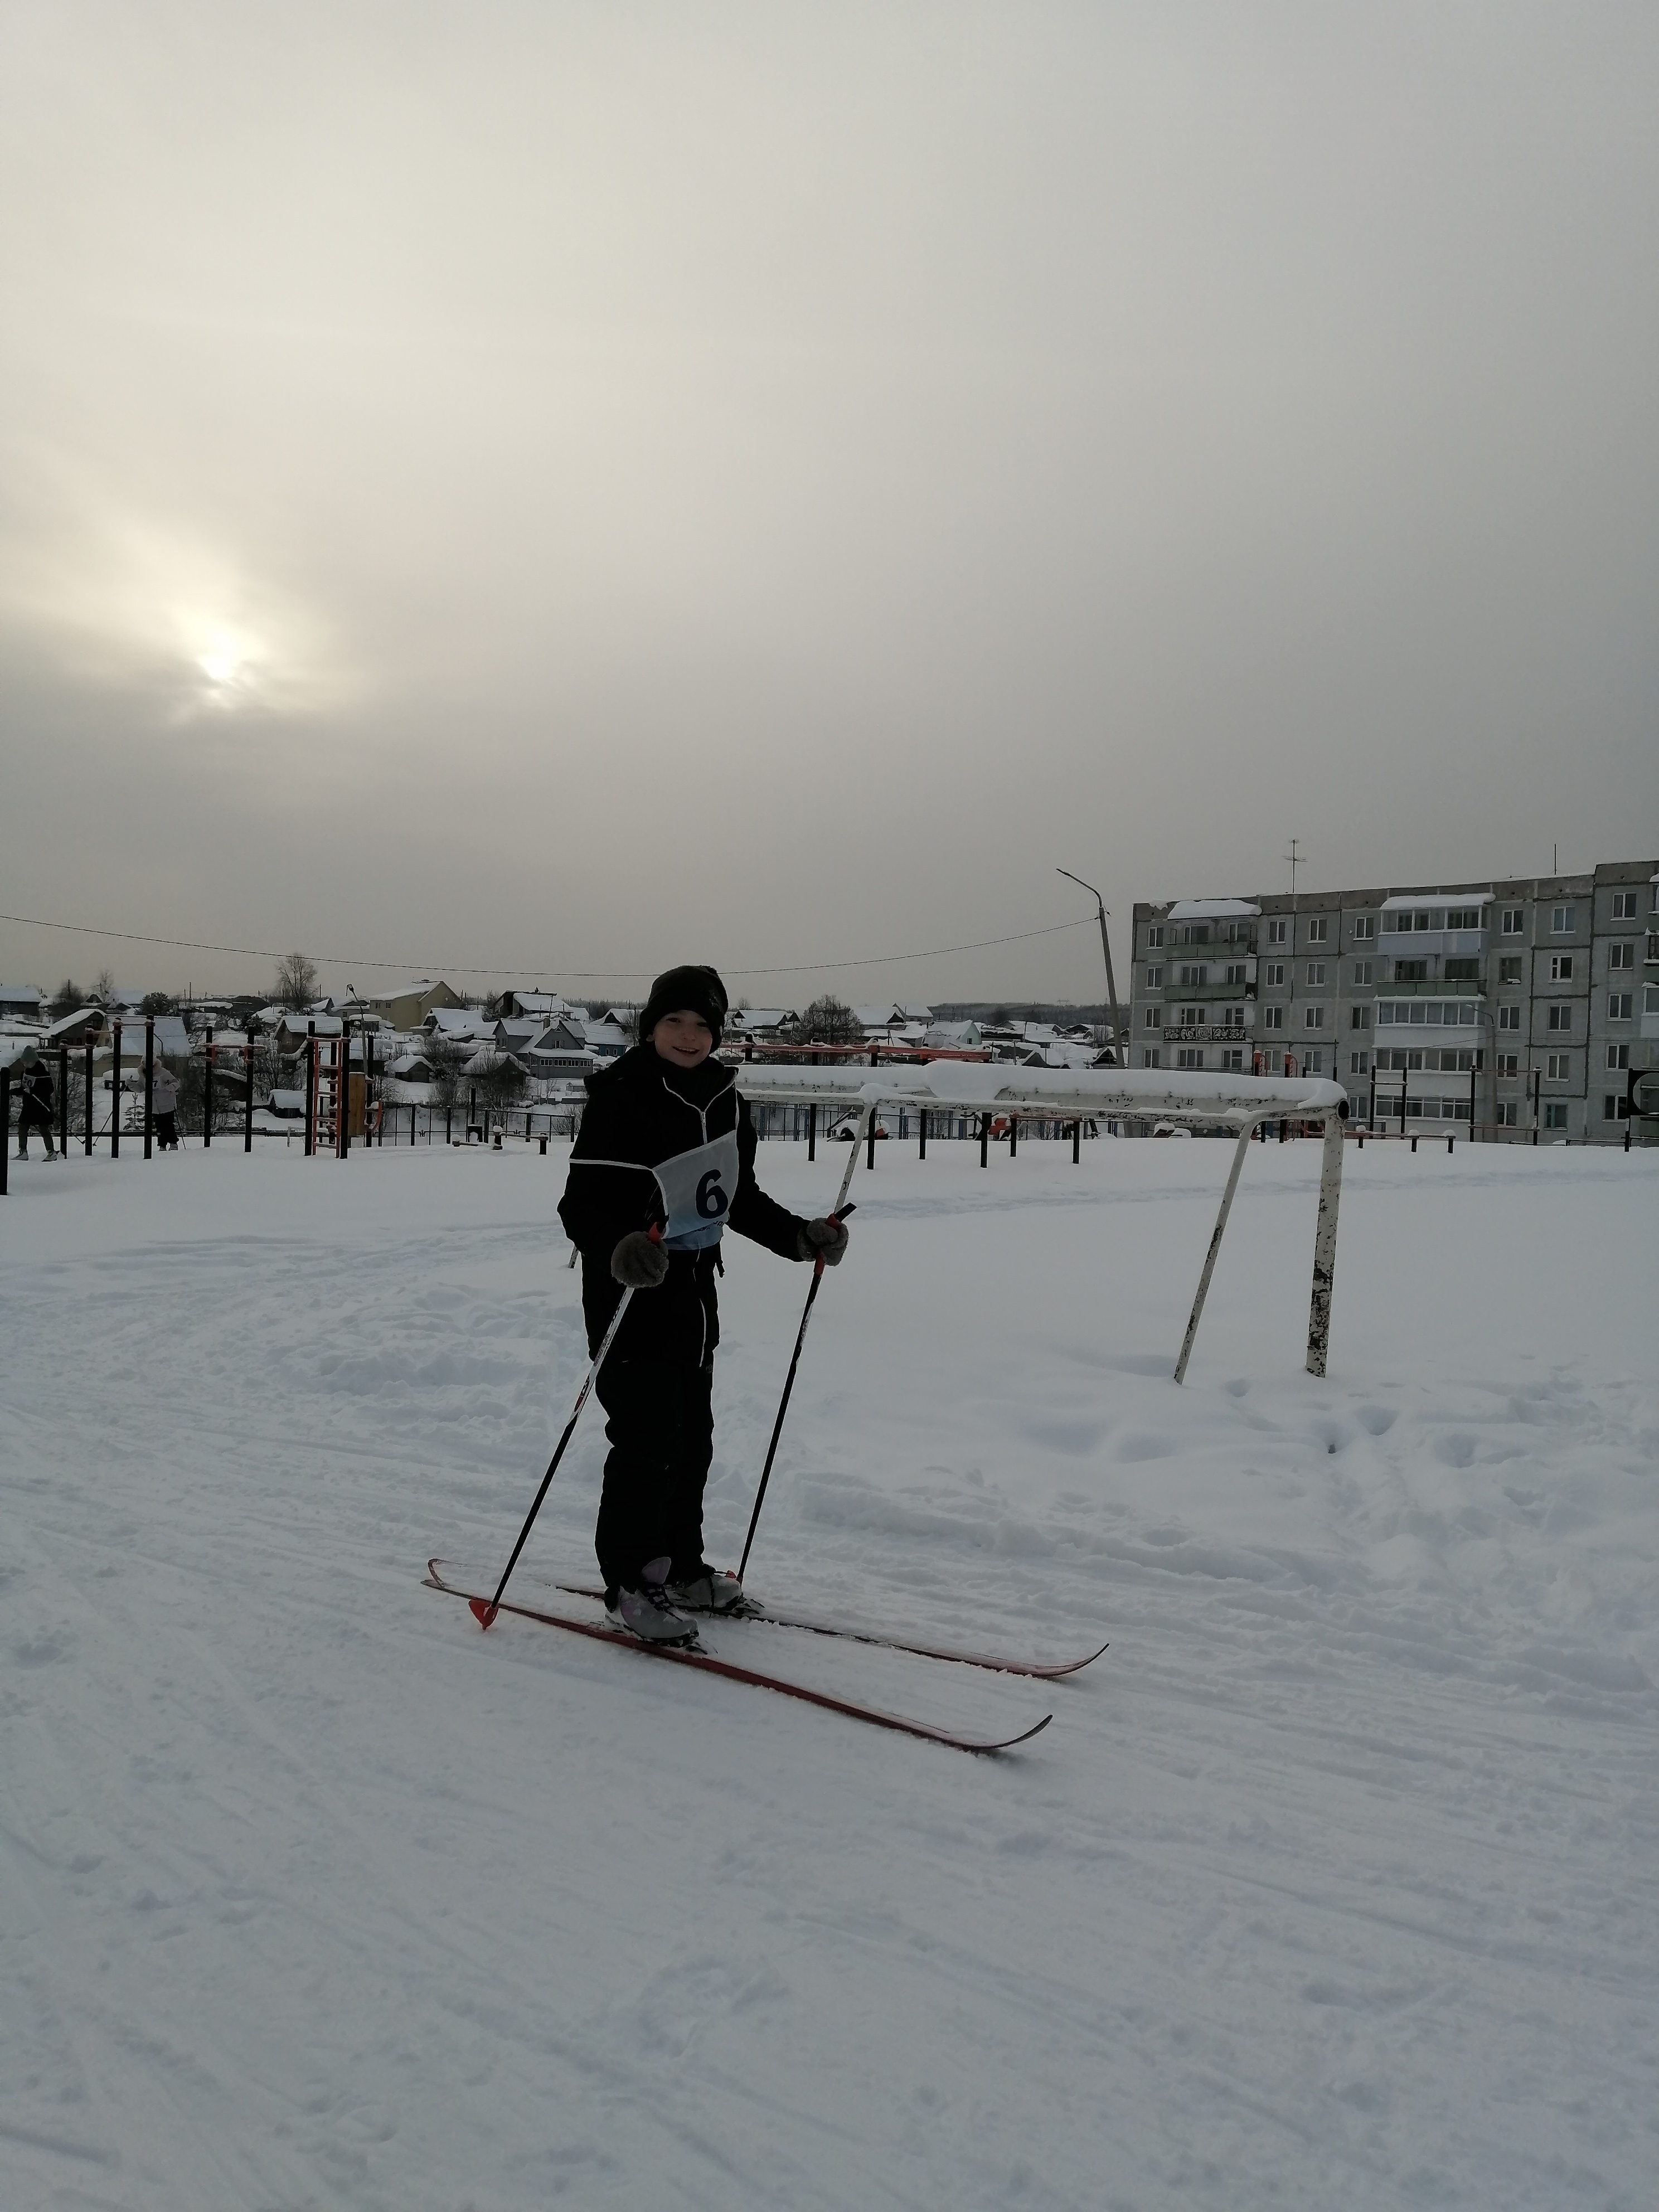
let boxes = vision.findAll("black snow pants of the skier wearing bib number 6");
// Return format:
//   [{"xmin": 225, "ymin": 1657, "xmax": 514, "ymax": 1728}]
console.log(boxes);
[{"xmin": 593, "ymin": 1358, "xmax": 715, "ymax": 1590}]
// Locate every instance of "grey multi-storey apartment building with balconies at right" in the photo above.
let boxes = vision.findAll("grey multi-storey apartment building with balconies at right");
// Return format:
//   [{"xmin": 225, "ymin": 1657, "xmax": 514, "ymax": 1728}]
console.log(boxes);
[{"xmin": 1131, "ymin": 861, "xmax": 1659, "ymax": 1143}]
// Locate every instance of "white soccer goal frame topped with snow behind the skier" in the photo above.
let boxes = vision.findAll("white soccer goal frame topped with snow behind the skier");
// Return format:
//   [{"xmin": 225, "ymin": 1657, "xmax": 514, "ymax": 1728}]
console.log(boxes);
[{"xmin": 734, "ymin": 1060, "xmax": 1347, "ymax": 1382}]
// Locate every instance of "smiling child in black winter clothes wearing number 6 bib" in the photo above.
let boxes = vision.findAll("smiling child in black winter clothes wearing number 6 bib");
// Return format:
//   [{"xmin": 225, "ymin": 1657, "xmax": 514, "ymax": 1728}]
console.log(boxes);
[{"xmin": 560, "ymin": 967, "xmax": 847, "ymax": 1643}]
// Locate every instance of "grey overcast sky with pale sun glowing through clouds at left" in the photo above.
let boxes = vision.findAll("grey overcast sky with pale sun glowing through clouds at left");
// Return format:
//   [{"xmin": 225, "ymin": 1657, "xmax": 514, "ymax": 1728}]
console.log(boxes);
[{"xmin": 0, "ymin": 0, "xmax": 1659, "ymax": 1004}]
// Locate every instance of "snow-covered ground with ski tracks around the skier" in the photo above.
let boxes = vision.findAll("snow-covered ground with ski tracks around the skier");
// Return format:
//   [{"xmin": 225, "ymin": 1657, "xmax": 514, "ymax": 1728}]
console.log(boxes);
[{"xmin": 0, "ymin": 1141, "xmax": 1659, "ymax": 2212}]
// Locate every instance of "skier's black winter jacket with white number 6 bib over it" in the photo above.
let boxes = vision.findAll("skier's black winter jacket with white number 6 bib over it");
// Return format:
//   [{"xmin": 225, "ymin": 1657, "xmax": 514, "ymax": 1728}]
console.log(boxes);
[{"xmin": 560, "ymin": 1044, "xmax": 805, "ymax": 1367}]
